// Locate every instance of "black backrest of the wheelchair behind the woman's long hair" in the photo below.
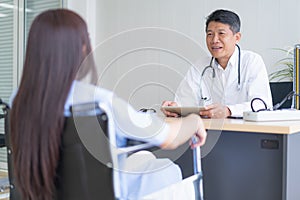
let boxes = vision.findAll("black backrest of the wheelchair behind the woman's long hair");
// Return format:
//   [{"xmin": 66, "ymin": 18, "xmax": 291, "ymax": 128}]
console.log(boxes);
[{"xmin": 5, "ymin": 103, "xmax": 115, "ymax": 200}]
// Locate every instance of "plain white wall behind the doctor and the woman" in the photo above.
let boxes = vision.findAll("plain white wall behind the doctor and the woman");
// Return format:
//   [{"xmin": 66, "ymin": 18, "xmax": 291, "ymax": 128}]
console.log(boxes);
[{"xmin": 68, "ymin": 0, "xmax": 300, "ymax": 108}]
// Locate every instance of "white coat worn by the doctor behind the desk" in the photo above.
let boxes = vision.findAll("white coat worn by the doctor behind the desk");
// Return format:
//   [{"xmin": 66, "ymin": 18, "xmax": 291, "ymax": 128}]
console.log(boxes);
[{"xmin": 175, "ymin": 47, "xmax": 272, "ymax": 116}]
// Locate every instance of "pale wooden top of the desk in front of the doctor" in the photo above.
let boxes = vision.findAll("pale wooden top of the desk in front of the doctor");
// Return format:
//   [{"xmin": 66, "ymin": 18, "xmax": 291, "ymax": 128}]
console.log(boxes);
[{"xmin": 203, "ymin": 119, "xmax": 300, "ymax": 134}]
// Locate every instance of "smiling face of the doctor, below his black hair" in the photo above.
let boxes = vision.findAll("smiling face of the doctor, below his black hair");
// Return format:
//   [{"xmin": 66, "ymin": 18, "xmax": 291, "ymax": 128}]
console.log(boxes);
[{"xmin": 206, "ymin": 21, "xmax": 241, "ymax": 68}]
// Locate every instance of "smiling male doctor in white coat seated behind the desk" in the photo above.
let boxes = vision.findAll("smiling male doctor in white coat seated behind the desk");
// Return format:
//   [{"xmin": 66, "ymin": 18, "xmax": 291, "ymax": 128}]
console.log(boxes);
[{"xmin": 162, "ymin": 10, "xmax": 272, "ymax": 118}]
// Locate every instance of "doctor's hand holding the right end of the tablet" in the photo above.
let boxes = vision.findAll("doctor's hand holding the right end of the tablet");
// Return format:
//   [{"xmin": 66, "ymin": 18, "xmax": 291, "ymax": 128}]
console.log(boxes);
[{"xmin": 199, "ymin": 103, "xmax": 231, "ymax": 118}]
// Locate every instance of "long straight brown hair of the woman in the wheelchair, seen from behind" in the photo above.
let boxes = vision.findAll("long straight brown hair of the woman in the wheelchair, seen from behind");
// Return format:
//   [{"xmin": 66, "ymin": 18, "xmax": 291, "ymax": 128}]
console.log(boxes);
[{"xmin": 11, "ymin": 9, "xmax": 96, "ymax": 200}]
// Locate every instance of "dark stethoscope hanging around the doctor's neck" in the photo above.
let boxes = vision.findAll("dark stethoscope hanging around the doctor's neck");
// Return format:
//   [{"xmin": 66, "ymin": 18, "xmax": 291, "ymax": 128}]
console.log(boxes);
[{"xmin": 200, "ymin": 44, "xmax": 241, "ymax": 101}]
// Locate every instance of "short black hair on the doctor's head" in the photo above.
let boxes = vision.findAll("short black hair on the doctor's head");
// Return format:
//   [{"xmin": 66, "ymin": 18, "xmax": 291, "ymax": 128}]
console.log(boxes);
[{"xmin": 205, "ymin": 9, "xmax": 241, "ymax": 34}]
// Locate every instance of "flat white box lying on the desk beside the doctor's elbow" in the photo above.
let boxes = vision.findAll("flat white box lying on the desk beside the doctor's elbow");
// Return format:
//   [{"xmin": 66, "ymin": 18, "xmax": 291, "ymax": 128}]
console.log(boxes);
[{"xmin": 243, "ymin": 109, "xmax": 300, "ymax": 122}]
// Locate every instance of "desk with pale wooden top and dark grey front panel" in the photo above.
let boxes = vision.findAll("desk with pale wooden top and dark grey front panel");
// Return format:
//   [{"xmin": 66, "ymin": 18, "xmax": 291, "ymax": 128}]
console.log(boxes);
[{"xmin": 177, "ymin": 119, "xmax": 300, "ymax": 200}]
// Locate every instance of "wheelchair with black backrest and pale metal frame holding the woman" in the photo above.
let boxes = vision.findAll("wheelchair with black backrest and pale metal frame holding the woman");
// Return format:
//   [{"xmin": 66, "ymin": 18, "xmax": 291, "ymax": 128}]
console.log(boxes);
[{"xmin": 0, "ymin": 99, "xmax": 203, "ymax": 200}]
